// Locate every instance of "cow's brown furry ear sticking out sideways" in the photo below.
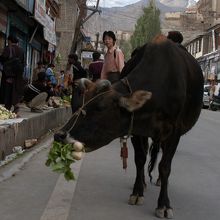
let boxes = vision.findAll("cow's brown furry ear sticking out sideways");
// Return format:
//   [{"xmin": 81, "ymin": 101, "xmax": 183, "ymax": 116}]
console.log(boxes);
[{"xmin": 119, "ymin": 90, "xmax": 152, "ymax": 112}]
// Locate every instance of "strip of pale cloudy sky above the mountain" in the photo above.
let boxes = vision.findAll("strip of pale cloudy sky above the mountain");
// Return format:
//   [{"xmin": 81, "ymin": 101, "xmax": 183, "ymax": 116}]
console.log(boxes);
[{"xmin": 87, "ymin": 0, "xmax": 198, "ymax": 8}]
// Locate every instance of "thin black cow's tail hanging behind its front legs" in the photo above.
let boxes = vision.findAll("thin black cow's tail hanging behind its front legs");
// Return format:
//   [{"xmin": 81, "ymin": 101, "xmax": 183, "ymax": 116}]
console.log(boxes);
[{"xmin": 148, "ymin": 141, "xmax": 160, "ymax": 182}]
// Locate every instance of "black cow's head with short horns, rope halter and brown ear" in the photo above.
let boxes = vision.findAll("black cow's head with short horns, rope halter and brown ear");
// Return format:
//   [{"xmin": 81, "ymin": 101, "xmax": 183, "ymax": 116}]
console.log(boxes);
[{"xmin": 54, "ymin": 79, "xmax": 151, "ymax": 152}]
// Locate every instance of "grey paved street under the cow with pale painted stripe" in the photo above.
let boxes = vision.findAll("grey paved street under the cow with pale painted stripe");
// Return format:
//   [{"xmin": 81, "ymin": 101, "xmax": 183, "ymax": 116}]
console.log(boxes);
[{"xmin": 0, "ymin": 110, "xmax": 220, "ymax": 220}]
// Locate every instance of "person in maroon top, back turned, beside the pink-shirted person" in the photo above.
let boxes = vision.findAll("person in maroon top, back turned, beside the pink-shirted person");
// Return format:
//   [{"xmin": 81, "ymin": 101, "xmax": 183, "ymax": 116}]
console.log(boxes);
[{"xmin": 89, "ymin": 51, "xmax": 103, "ymax": 82}]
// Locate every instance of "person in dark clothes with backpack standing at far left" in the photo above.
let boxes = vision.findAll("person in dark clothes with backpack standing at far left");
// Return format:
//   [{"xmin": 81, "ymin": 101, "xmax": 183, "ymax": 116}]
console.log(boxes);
[{"xmin": 0, "ymin": 35, "xmax": 24, "ymax": 113}]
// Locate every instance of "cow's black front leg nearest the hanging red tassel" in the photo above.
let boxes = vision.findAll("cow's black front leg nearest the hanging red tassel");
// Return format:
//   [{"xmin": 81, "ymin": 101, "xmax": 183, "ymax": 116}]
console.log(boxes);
[{"xmin": 129, "ymin": 135, "xmax": 148, "ymax": 205}]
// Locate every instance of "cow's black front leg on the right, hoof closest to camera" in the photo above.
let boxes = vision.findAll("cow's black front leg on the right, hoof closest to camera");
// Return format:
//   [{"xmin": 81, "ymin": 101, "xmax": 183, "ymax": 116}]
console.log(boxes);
[{"xmin": 156, "ymin": 131, "xmax": 180, "ymax": 218}]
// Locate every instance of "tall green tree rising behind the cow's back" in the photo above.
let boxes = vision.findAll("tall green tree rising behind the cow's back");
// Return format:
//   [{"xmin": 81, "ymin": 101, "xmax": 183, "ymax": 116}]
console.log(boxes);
[{"xmin": 131, "ymin": 0, "xmax": 161, "ymax": 49}]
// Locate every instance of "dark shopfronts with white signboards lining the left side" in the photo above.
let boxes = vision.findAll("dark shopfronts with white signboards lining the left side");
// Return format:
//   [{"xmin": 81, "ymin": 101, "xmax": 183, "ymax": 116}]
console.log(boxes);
[{"xmin": 0, "ymin": 0, "xmax": 59, "ymax": 81}]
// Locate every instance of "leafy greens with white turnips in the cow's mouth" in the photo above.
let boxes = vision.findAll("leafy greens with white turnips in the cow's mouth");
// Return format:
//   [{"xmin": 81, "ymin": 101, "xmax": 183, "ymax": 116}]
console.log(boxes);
[{"xmin": 46, "ymin": 141, "xmax": 84, "ymax": 181}]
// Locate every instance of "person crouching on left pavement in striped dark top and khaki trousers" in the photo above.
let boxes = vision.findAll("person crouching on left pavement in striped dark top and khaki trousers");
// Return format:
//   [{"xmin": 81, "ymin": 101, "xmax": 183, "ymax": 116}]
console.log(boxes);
[{"xmin": 23, "ymin": 72, "xmax": 53, "ymax": 113}]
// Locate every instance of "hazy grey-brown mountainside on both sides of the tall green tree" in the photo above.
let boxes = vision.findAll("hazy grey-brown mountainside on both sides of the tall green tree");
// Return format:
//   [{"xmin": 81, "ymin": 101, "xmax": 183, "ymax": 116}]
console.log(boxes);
[{"xmin": 84, "ymin": 0, "xmax": 201, "ymax": 44}]
